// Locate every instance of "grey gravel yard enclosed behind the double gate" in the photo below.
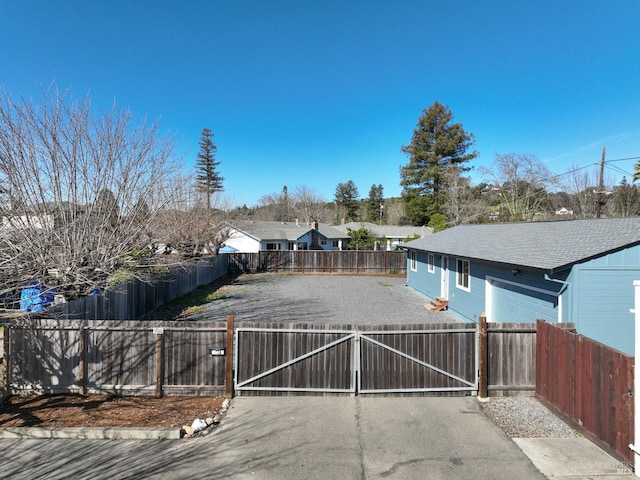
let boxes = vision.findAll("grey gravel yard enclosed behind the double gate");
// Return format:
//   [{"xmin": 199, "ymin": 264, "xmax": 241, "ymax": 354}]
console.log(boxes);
[{"xmin": 192, "ymin": 274, "xmax": 459, "ymax": 325}]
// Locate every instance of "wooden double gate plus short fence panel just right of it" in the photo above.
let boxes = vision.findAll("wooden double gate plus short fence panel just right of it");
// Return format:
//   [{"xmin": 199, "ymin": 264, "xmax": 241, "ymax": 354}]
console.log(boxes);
[{"xmin": 236, "ymin": 322, "xmax": 536, "ymax": 395}]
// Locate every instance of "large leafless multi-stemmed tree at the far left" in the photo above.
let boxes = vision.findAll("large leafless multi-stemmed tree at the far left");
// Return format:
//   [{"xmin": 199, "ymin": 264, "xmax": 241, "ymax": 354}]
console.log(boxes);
[{"xmin": 0, "ymin": 88, "xmax": 188, "ymax": 298}]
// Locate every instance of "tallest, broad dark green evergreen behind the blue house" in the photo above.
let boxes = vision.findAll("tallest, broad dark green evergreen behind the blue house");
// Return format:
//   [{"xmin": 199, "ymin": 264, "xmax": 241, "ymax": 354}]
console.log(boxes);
[{"xmin": 400, "ymin": 102, "xmax": 478, "ymax": 225}]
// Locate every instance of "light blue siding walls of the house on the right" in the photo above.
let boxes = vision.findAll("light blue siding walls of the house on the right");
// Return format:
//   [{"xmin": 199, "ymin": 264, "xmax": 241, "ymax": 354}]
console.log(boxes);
[{"xmin": 407, "ymin": 246, "xmax": 640, "ymax": 354}]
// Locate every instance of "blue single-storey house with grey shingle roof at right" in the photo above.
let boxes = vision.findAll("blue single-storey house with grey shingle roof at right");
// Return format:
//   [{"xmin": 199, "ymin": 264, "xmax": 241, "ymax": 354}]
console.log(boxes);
[{"xmin": 405, "ymin": 218, "xmax": 640, "ymax": 354}]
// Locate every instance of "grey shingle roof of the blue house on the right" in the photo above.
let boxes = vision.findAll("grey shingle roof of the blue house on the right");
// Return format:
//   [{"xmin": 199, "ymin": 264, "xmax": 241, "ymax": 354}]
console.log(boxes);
[{"xmin": 405, "ymin": 218, "xmax": 640, "ymax": 272}]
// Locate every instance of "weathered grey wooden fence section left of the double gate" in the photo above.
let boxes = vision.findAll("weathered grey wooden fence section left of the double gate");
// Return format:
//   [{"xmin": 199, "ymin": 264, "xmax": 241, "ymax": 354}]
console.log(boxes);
[{"xmin": 4, "ymin": 318, "xmax": 233, "ymax": 396}]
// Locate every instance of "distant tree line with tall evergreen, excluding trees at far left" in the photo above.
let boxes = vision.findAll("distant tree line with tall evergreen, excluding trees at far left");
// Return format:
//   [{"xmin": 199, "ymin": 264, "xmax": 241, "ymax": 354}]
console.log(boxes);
[{"xmin": 233, "ymin": 102, "xmax": 640, "ymax": 231}]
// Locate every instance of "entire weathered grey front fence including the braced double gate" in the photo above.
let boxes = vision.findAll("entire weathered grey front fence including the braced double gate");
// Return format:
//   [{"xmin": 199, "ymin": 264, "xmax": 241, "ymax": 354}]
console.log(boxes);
[{"xmin": 4, "ymin": 319, "xmax": 535, "ymax": 396}]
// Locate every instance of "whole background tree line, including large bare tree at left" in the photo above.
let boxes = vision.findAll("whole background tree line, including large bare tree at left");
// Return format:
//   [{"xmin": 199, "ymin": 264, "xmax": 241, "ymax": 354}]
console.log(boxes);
[{"xmin": 0, "ymin": 88, "xmax": 640, "ymax": 299}]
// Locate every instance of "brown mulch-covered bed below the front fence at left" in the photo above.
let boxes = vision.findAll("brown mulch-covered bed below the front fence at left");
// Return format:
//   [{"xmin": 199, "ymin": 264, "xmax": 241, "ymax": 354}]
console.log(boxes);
[{"xmin": 0, "ymin": 395, "xmax": 224, "ymax": 428}]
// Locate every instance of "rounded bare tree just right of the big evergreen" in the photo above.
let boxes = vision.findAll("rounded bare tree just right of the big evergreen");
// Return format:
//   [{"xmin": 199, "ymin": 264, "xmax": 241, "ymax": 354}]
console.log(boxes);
[{"xmin": 480, "ymin": 153, "xmax": 554, "ymax": 221}]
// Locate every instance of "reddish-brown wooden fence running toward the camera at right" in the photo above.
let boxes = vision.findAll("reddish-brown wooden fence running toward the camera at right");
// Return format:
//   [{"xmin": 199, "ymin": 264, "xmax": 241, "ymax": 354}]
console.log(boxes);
[{"xmin": 536, "ymin": 320, "xmax": 640, "ymax": 462}]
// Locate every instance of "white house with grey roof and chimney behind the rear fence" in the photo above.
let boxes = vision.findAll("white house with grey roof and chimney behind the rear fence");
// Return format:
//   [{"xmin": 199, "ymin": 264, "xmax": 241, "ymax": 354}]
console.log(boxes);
[{"xmin": 224, "ymin": 221, "xmax": 349, "ymax": 253}]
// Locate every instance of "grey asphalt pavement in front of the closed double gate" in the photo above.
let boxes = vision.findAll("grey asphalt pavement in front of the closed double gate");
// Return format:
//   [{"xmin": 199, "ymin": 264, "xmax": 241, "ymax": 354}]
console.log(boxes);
[{"xmin": 0, "ymin": 397, "xmax": 545, "ymax": 480}]
